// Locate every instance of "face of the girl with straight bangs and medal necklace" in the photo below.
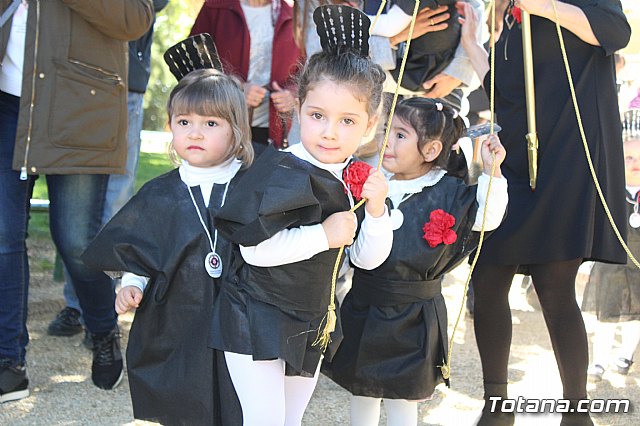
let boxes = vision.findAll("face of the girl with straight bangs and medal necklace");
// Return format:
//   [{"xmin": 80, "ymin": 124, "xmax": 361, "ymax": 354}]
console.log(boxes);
[{"xmin": 170, "ymin": 113, "xmax": 233, "ymax": 167}]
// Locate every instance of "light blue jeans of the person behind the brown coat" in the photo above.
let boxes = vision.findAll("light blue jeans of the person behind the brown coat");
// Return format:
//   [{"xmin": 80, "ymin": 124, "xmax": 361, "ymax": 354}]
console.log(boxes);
[{"xmin": 64, "ymin": 92, "xmax": 144, "ymax": 312}]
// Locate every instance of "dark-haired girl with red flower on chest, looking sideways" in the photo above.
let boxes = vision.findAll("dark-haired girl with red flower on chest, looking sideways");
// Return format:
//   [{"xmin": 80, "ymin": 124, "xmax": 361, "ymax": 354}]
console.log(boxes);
[{"xmin": 323, "ymin": 98, "xmax": 507, "ymax": 426}]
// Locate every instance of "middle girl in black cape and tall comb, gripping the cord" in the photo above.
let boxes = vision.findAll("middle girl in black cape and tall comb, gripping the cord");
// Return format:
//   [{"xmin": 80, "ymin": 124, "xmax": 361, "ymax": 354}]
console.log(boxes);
[{"xmin": 211, "ymin": 6, "xmax": 392, "ymax": 425}]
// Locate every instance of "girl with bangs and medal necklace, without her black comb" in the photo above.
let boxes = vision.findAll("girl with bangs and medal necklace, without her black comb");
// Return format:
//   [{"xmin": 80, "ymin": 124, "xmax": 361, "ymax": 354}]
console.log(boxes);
[{"xmin": 83, "ymin": 64, "xmax": 253, "ymax": 425}]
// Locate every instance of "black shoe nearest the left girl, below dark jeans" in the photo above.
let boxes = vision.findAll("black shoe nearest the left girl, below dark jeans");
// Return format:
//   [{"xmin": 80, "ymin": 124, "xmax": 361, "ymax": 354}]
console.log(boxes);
[{"xmin": 91, "ymin": 327, "xmax": 124, "ymax": 389}]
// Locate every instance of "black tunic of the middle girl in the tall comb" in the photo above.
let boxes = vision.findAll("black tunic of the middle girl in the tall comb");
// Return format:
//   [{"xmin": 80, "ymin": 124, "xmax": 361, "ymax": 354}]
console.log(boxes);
[{"xmin": 210, "ymin": 149, "xmax": 362, "ymax": 377}]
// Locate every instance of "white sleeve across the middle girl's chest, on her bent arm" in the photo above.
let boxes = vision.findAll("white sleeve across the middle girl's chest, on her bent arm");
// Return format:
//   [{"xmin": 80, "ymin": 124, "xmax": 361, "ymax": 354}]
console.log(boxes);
[{"xmin": 240, "ymin": 224, "xmax": 329, "ymax": 267}]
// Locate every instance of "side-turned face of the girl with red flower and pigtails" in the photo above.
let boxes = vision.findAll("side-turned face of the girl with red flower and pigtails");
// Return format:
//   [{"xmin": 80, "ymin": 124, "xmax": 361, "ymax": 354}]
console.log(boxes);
[{"xmin": 382, "ymin": 117, "xmax": 429, "ymax": 180}]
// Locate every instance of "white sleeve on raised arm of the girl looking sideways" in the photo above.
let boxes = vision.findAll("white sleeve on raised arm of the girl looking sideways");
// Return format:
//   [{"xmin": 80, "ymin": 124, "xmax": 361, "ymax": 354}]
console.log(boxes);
[{"xmin": 472, "ymin": 173, "xmax": 509, "ymax": 231}]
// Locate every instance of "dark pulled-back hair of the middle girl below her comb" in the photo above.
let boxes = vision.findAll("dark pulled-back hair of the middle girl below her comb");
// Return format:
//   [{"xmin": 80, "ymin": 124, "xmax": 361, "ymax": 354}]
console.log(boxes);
[{"xmin": 298, "ymin": 47, "xmax": 385, "ymax": 117}]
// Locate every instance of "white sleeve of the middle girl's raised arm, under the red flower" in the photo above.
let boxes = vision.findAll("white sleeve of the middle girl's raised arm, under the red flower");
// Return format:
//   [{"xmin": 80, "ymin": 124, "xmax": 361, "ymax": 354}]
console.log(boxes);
[{"xmin": 349, "ymin": 206, "xmax": 393, "ymax": 270}]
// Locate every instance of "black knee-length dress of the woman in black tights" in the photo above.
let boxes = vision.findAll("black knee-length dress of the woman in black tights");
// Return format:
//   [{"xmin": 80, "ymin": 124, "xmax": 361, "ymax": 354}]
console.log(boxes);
[{"xmin": 480, "ymin": 0, "xmax": 630, "ymax": 265}]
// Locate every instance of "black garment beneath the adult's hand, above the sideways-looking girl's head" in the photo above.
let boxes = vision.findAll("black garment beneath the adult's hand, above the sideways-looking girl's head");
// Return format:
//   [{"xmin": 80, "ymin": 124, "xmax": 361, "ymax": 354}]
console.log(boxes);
[{"xmin": 391, "ymin": 0, "xmax": 460, "ymax": 91}]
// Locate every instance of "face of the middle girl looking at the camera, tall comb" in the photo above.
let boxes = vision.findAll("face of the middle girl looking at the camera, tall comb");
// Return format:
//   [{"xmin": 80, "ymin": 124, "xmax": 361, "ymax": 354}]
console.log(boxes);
[{"xmin": 300, "ymin": 80, "xmax": 375, "ymax": 164}]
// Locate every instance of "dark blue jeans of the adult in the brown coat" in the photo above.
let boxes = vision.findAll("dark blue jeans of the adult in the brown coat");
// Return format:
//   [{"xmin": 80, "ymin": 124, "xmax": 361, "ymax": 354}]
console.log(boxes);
[{"xmin": 0, "ymin": 92, "xmax": 117, "ymax": 362}]
